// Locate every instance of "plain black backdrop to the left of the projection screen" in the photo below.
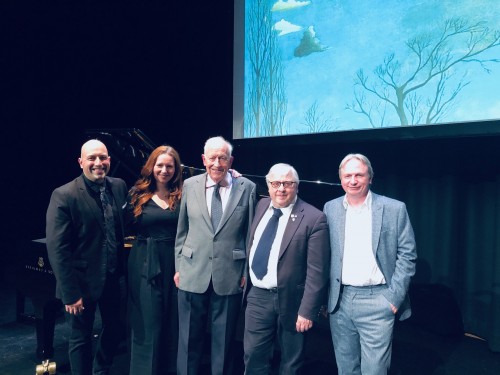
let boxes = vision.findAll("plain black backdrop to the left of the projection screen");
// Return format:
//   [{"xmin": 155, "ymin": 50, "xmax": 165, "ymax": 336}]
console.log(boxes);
[{"xmin": 0, "ymin": 0, "xmax": 233, "ymax": 238}]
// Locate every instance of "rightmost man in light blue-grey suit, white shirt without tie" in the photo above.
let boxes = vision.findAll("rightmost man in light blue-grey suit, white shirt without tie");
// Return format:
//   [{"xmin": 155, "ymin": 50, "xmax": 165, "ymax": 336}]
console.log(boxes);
[{"xmin": 324, "ymin": 154, "xmax": 417, "ymax": 375}]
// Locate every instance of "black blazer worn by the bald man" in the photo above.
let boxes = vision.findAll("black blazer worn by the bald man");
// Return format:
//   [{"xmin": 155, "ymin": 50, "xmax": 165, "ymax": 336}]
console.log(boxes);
[{"xmin": 46, "ymin": 175, "xmax": 127, "ymax": 305}]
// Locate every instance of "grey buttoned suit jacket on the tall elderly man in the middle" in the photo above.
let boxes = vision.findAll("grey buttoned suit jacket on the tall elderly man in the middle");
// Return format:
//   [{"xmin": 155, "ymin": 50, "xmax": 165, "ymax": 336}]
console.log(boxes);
[{"xmin": 175, "ymin": 173, "xmax": 256, "ymax": 295}]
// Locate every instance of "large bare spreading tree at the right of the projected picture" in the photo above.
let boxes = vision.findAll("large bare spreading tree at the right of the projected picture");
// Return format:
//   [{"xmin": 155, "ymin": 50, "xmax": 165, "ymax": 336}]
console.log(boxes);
[{"xmin": 347, "ymin": 19, "xmax": 500, "ymax": 127}]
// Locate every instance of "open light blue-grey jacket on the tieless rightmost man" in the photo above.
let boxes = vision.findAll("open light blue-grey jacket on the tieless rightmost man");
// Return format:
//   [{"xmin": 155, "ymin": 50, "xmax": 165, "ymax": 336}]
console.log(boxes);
[{"xmin": 323, "ymin": 193, "xmax": 417, "ymax": 320}]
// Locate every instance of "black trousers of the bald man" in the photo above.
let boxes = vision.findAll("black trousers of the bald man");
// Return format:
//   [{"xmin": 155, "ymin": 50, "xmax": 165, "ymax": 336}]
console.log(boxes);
[{"xmin": 68, "ymin": 273, "xmax": 125, "ymax": 375}]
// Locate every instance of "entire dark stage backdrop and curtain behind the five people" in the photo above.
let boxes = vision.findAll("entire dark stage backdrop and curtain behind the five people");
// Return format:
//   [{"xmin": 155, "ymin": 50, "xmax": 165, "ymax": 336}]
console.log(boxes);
[{"xmin": 0, "ymin": 0, "xmax": 500, "ymax": 351}]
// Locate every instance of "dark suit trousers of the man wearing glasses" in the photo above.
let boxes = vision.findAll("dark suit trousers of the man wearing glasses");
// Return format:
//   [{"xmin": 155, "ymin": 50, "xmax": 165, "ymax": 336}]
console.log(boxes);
[{"xmin": 243, "ymin": 286, "xmax": 305, "ymax": 375}]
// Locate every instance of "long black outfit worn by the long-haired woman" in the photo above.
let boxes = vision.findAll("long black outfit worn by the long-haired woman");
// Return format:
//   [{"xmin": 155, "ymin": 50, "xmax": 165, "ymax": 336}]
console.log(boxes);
[{"xmin": 128, "ymin": 199, "xmax": 179, "ymax": 375}]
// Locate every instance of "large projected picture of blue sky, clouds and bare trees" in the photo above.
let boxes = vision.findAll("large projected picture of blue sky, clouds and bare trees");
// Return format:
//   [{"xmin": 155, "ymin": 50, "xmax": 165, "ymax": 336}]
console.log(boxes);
[{"xmin": 242, "ymin": 0, "xmax": 500, "ymax": 137}]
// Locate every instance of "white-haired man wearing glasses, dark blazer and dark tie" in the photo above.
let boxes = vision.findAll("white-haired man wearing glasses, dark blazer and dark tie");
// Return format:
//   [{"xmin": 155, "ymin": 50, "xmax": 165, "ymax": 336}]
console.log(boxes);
[{"xmin": 243, "ymin": 163, "xmax": 330, "ymax": 375}]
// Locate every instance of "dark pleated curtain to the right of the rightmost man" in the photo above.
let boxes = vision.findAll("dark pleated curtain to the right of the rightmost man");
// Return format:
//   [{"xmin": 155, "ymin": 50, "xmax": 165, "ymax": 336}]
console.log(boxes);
[{"xmin": 373, "ymin": 175, "xmax": 500, "ymax": 352}]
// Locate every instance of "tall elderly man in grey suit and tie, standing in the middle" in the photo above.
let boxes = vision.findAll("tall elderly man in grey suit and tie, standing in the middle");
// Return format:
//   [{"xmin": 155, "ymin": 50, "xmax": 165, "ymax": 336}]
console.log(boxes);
[{"xmin": 174, "ymin": 137, "xmax": 256, "ymax": 375}]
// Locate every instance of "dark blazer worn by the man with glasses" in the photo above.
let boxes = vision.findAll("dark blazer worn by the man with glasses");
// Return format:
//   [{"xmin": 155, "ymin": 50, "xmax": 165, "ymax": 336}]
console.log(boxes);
[{"xmin": 244, "ymin": 198, "xmax": 330, "ymax": 331}]
